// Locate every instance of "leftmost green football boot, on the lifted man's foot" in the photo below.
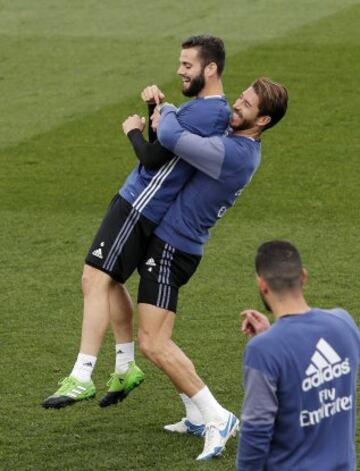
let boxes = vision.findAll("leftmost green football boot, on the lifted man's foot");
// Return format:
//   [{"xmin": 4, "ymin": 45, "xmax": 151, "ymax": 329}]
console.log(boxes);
[{"xmin": 41, "ymin": 376, "xmax": 96, "ymax": 409}]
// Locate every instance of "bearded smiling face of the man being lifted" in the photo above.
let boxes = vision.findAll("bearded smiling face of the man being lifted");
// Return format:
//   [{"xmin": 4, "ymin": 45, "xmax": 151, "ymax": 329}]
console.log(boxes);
[{"xmin": 177, "ymin": 47, "xmax": 206, "ymax": 97}]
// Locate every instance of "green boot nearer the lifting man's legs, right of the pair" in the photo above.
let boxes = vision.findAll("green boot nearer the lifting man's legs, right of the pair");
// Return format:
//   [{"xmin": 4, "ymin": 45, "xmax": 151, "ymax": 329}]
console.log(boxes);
[{"xmin": 100, "ymin": 361, "xmax": 144, "ymax": 407}]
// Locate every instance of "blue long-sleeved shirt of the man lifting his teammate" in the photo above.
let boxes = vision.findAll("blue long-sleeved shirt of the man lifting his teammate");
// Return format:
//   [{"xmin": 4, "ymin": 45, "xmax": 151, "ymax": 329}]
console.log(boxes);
[{"xmin": 155, "ymin": 105, "xmax": 261, "ymax": 255}]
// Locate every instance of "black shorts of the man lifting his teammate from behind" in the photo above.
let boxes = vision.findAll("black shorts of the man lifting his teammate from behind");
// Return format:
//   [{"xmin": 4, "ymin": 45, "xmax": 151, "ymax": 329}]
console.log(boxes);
[{"xmin": 138, "ymin": 236, "xmax": 201, "ymax": 312}]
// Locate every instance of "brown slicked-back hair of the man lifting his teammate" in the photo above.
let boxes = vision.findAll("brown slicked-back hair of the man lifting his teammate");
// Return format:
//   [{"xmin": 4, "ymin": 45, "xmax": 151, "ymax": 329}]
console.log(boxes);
[{"xmin": 251, "ymin": 77, "xmax": 288, "ymax": 130}]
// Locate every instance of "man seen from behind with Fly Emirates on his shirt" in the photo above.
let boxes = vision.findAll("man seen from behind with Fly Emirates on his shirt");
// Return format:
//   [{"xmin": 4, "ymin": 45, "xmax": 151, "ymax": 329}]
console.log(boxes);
[{"xmin": 236, "ymin": 241, "xmax": 360, "ymax": 471}]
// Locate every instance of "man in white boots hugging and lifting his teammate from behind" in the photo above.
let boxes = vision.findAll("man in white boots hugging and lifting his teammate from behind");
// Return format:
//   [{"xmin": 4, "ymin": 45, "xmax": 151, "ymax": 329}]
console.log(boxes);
[{"xmin": 125, "ymin": 78, "xmax": 288, "ymax": 460}]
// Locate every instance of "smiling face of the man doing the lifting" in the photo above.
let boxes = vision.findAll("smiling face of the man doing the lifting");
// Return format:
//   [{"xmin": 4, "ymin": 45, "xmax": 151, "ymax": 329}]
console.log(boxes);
[{"xmin": 230, "ymin": 87, "xmax": 259, "ymax": 131}]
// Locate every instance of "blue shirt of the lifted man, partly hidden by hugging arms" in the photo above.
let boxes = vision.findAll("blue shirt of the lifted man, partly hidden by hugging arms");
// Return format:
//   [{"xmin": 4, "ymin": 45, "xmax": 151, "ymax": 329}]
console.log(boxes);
[{"xmin": 119, "ymin": 96, "xmax": 230, "ymax": 224}]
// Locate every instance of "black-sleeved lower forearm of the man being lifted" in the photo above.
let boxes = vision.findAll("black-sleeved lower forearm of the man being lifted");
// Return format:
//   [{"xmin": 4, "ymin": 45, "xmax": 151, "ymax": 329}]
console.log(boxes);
[{"xmin": 127, "ymin": 129, "xmax": 173, "ymax": 170}]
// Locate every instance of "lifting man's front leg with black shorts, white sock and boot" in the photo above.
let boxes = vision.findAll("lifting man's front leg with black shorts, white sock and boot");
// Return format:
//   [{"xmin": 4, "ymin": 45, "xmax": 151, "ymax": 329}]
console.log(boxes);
[{"xmin": 138, "ymin": 237, "xmax": 238, "ymax": 459}]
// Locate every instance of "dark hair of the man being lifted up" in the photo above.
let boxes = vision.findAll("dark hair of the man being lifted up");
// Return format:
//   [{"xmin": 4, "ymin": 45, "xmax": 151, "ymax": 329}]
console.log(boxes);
[{"xmin": 181, "ymin": 34, "xmax": 225, "ymax": 77}]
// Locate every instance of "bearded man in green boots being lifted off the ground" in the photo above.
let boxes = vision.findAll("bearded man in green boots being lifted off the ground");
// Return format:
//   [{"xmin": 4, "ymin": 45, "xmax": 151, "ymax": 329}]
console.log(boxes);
[{"xmin": 42, "ymin": 35, "xmax": 230, "ymax": 408}]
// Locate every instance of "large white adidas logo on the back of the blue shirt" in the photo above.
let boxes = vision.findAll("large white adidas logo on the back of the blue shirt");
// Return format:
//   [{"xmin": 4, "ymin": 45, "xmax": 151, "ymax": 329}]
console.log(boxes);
[{"xmin": 302, "ymin": 338, "xmax": 350, "ymax": 392}]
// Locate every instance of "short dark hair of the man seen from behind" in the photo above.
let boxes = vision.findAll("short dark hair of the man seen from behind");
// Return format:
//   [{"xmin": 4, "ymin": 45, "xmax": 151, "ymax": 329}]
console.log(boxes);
[{"xmin": 255, "ymin": 240, "xmax": 303, "ymax": 292}]
